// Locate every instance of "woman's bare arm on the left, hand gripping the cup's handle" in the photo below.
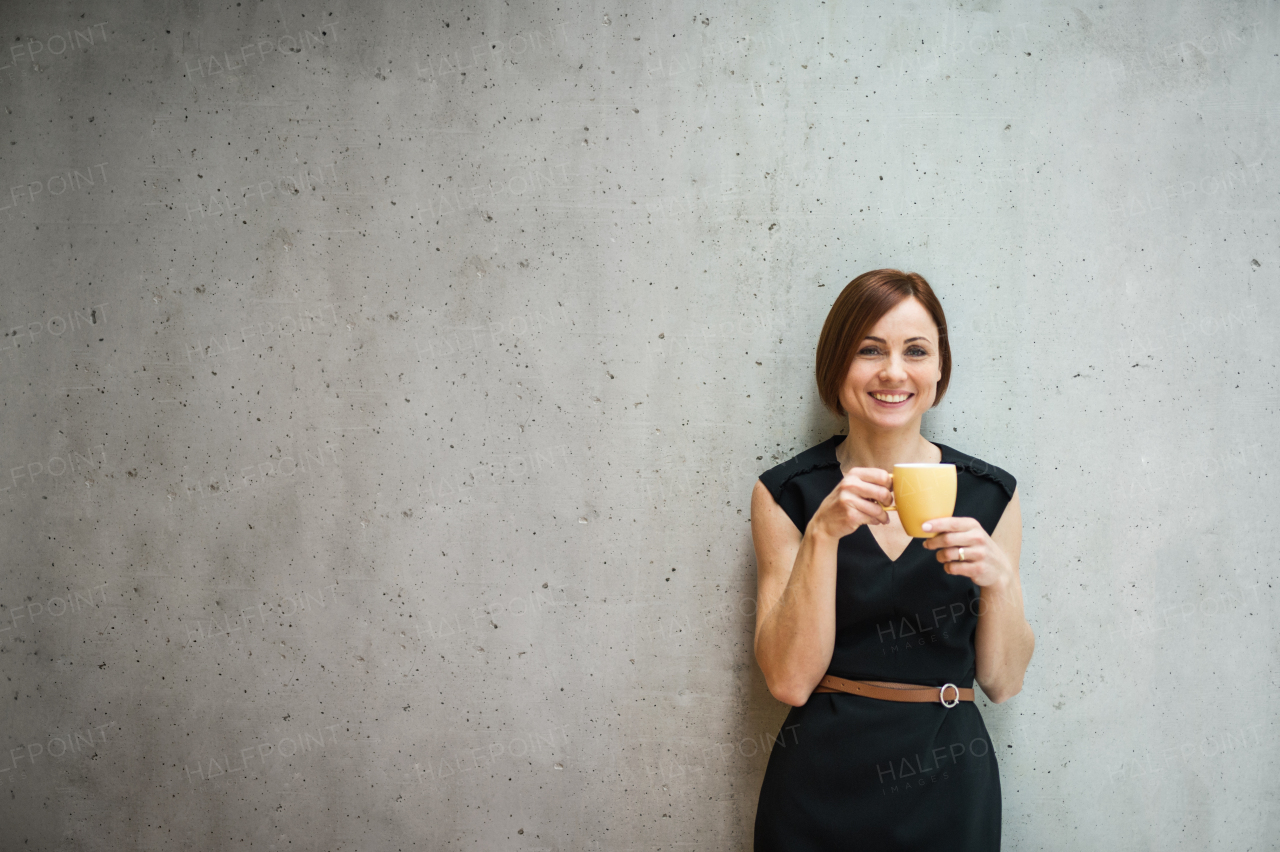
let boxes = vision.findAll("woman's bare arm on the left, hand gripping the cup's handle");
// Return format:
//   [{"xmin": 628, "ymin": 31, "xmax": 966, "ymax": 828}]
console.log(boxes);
[{"xmin": 751, "ymin": 468, "xmax": 892, "ymax": 707}]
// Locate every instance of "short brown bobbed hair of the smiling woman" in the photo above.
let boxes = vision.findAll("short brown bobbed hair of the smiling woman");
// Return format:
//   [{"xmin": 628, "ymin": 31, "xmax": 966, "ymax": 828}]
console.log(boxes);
[{"xmin": 817, "ymin": 269, "xmax": 951, "ymax": 417}]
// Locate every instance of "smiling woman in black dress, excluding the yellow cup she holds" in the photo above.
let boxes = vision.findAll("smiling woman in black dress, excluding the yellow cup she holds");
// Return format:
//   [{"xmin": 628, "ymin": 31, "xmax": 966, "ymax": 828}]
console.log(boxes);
[{"xmin": 751, "ymin": 269, "xmax": 1036, "ymax": 852}]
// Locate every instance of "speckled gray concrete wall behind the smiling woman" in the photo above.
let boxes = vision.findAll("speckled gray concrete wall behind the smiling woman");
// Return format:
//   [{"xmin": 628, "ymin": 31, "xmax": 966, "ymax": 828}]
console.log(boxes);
[{"xmin": 0, "ymin": 0, "xmax": 1280, "ymax": 852}]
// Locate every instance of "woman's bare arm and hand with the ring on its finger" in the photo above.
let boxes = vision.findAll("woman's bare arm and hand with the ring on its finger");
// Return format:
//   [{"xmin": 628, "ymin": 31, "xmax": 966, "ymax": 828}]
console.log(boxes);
[{"xmin": 924, "ymin": 489, "xmax": 1036, "ymax": 704}]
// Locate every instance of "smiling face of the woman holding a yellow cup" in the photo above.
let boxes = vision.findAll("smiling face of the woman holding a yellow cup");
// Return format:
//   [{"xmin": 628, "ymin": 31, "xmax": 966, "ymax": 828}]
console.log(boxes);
[{"xmin": 840, "ymin": 298, "xmax": 942, "ymax": 430}]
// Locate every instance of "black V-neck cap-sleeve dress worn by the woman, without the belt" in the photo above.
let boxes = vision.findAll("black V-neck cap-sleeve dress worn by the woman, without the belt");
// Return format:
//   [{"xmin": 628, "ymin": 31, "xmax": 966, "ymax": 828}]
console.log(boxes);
[{"xmin": 755, "ymin": 435, "xmax": 1016, "ymax": 852}]
